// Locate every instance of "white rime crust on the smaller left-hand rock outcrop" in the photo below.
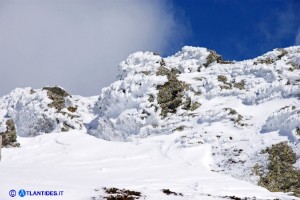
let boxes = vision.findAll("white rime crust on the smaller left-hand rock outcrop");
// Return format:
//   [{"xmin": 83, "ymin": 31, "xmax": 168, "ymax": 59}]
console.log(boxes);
[{"xmin": 0, "ymin": 88, "xmax": 93, "ymax": 137}]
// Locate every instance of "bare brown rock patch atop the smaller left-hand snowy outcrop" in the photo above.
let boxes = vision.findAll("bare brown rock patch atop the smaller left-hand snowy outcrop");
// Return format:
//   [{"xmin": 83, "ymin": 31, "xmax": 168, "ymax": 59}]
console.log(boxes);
[{"xmin": 43, "ymin": 86, "xmax": 70, "ymax": 111}]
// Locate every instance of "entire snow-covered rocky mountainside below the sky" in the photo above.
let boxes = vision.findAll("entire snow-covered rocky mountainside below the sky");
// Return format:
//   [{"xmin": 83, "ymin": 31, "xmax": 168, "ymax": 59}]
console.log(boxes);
[{"xmin": 0, "ymin": 46, "xmax": 300, "ymax": 199}]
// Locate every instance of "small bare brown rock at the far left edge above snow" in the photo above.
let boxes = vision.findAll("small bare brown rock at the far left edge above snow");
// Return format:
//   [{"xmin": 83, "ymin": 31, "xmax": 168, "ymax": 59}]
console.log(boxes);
[{"xmin": 0, "ymin": 119, "xmax": 20, "ymax": 147}]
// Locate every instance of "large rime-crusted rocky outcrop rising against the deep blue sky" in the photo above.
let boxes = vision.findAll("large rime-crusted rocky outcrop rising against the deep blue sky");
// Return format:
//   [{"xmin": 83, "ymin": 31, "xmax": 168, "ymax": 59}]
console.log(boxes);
[{"xmin": 86, "ymin": 47, "xmax": 300, "ymax": 197}]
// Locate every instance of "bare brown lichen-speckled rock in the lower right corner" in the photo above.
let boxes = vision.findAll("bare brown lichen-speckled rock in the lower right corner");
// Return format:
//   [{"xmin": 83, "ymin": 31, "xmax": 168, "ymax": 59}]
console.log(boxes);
[{"xmin": 254, "ymin": 142, "xmax": 300, "ymax": 197}]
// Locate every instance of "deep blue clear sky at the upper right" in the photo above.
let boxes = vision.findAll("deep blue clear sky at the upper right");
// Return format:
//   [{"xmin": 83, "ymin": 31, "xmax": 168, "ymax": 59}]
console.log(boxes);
[{"xmin": 173, "ymin": 0, "xmax": 300, "ymax": 60}]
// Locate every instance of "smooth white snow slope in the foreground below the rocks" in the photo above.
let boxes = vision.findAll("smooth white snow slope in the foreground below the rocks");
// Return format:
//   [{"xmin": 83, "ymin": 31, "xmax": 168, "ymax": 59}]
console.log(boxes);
[{"xmin": 0, "ymin": 131, "xmax": 296, "ymax": 200}]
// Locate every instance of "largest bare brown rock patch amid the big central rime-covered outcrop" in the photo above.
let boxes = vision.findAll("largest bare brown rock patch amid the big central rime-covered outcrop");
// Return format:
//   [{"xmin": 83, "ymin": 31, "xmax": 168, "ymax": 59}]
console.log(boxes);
[{"xmin": 156, "ymin": 60, "xmax": 188, "ymax": 117}]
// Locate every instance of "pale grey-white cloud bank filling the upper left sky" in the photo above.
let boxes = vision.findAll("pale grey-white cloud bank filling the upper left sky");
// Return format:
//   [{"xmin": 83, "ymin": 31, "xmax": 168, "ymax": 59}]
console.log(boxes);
[{"xmin": 0, "ymin": 0, "xmax": 185, "ymax": 95}]
